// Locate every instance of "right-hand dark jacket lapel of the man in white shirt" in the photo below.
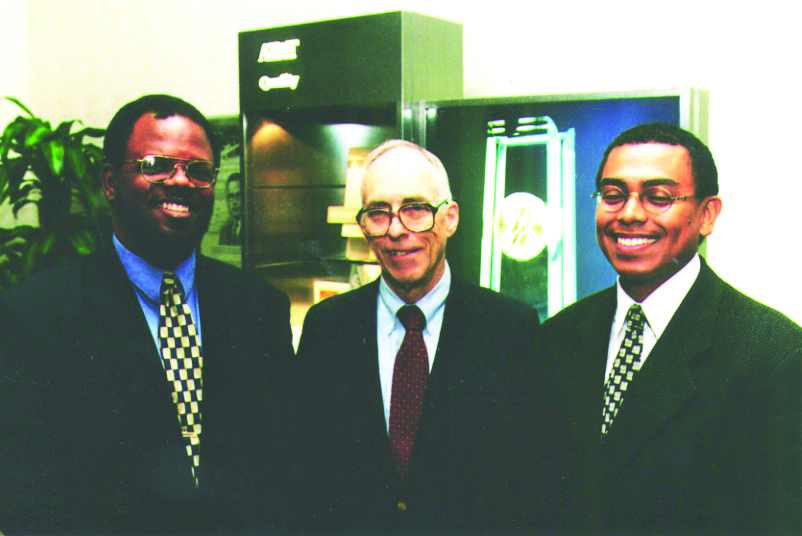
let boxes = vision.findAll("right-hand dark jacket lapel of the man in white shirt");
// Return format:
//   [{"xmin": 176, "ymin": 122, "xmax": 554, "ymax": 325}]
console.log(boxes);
[{"xmin": 607, "ymin": 262, "xmax": 723, "ymax": 471}]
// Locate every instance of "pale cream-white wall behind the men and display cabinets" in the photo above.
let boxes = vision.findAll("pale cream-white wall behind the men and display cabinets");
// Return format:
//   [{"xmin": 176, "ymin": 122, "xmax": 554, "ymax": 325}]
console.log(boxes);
[{"xmin": 6, "ymin": 0, "xmax": 802, "ymax": 322}]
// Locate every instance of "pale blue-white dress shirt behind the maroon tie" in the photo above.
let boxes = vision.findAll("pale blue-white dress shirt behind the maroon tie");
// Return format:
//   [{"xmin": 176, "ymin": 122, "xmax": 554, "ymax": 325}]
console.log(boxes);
[{"xmin": 376, "ymin": 263, "xmax": 451, "ymax": 433}]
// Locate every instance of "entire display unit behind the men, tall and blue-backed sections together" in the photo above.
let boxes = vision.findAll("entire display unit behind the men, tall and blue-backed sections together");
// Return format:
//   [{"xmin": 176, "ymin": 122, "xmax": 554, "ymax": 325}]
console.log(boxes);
[{"xmin": 234, "ymin": 12, "xmax": 707, "ymax": 329}]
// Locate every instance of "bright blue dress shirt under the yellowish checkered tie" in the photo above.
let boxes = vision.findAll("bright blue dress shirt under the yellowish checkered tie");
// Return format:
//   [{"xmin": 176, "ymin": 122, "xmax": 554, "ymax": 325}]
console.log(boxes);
[{"xmin": 113, "ymin": 235, "xmax": 203, "ymax": 357}]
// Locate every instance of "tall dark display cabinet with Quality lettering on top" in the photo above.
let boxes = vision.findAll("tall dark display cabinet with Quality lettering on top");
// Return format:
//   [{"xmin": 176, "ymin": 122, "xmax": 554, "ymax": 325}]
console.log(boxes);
[{"xmin": 239, "ymin": 12, "xmax": 462, "ymax": 328}]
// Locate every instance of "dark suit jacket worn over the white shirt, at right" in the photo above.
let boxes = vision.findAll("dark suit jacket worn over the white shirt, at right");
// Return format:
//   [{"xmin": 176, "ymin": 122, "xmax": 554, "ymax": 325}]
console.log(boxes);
[{"xmin": 540, "ymin": 261, "xmax": 802, "ymax": 534}]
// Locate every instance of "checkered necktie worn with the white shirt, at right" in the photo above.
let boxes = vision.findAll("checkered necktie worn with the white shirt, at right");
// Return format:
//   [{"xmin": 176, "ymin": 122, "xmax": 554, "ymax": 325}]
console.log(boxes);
[{"xmin": 602, "ymin": 303, "xmax": 646, "ymax": 439}]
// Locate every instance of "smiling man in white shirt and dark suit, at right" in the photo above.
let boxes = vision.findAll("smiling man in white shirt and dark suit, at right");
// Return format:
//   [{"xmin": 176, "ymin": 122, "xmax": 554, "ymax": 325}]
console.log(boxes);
[{"xmin": 540, "ymin": 123, "xmax": 802, "ymax": 534}]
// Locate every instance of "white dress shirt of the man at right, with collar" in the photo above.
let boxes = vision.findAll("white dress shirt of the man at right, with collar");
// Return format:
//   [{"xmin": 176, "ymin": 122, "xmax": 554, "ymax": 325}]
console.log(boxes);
[{"xmin": 602, "ymin": 254, "xmax": 702, "ymax": 382}]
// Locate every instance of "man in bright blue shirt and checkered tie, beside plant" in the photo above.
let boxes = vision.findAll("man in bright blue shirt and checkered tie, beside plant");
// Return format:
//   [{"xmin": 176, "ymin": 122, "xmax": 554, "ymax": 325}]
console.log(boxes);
[{"xmin": 0, "ymin": 95, "xmax": 292, "ymax": 534}]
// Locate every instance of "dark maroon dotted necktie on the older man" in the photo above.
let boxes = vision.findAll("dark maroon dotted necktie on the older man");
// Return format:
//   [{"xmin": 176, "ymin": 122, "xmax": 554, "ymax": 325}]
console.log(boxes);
[{"xmin": 390, "ymin": 305, "xmax": 429, "ymax": 481}]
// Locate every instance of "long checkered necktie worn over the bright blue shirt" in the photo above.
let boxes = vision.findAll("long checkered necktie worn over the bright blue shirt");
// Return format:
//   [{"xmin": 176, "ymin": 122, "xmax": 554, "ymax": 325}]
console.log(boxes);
[{"xmin": 159, "ymin": 272, "xmax": 203, "ymax": 487}]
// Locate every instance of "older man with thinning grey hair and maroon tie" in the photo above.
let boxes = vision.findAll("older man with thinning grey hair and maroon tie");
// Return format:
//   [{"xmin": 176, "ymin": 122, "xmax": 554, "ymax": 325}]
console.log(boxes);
[{"xmin": 299, "ymin": 140, "xmax": 538, "ymax": 532}]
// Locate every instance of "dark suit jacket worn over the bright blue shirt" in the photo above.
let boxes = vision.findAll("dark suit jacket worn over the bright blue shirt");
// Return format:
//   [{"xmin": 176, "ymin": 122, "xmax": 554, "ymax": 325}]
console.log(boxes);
[{"xmin": 0, "ymin": 244, "xmax": 292, "ymax": 534}]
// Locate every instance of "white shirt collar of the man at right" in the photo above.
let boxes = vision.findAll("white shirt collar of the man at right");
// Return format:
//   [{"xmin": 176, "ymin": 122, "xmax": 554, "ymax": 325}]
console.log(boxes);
[{"xmin": 613, "ymin": 253, "xmax": 702, "ymax": 339}]
